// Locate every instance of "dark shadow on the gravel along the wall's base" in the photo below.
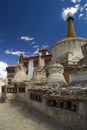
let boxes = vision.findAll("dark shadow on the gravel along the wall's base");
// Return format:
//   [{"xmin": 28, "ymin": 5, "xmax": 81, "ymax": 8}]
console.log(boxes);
[{"xmin": 10, "ymin": 101, "xmax": 62, "ymax": 130}]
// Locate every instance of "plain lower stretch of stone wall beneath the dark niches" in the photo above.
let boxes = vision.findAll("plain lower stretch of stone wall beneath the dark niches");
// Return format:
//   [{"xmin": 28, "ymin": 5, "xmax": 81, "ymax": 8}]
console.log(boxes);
[{"xmin": 16, "ymin": 92, "xmax": 87, "ymax": 130}]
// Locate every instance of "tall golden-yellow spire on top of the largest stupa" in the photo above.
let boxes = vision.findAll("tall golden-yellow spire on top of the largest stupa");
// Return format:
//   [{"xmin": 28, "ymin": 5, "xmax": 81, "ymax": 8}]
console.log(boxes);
[{"xmin": 67, "ymin": 13, "xmax": 76, "ymax": 37}]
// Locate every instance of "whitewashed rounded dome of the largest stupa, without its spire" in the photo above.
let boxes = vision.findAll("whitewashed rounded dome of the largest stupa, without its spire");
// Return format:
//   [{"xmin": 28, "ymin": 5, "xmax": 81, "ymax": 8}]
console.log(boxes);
[{"xmin": 51, "ymin": 38, "xmax": 87, "ymax": 63}]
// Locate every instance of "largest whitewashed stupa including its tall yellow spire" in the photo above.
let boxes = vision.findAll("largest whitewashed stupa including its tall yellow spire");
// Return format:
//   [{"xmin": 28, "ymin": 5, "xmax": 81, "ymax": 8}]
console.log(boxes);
[{"xmin": 51, "ymin": 14, "xmax": 87, "ymax": 83}]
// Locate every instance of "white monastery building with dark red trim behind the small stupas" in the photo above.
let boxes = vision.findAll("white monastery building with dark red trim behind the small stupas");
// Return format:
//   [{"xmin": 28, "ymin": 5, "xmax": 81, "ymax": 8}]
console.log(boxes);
[{"xmin": 6, "ymin": 48, "xmax": 52, "ymax": 81}]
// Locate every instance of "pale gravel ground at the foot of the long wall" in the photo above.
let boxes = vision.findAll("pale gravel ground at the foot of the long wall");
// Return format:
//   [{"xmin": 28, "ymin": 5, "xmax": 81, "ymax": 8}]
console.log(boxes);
[{"xmin": 0, "ymin": 102, "xmax": 61, "ymax": 130}]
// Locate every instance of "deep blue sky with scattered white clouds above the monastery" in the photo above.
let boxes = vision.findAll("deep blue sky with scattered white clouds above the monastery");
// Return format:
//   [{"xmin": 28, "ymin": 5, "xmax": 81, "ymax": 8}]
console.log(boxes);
[{"xmin": 0, "ymin": 0, "xmax": 87, "ymax": 77}]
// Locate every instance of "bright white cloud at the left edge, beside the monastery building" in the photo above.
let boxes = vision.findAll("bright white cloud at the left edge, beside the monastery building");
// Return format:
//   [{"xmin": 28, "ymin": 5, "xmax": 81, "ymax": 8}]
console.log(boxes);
[{"xmin": 0, "ymin": 61, "xmax": 8, "ymax": 78}]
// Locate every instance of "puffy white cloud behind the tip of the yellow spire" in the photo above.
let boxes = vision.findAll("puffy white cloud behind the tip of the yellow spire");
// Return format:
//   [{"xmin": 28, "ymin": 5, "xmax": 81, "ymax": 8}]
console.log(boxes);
[{"xmin": 62, "ymin": 4, "xmax": 80, "ymax": 20}]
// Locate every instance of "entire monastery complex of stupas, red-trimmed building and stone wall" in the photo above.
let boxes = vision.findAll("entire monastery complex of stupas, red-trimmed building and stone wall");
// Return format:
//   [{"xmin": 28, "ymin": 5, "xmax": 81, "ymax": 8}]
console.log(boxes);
[{"xmin": 1, "ymin": 14, "xmax": 87, "ymax": 130}]
